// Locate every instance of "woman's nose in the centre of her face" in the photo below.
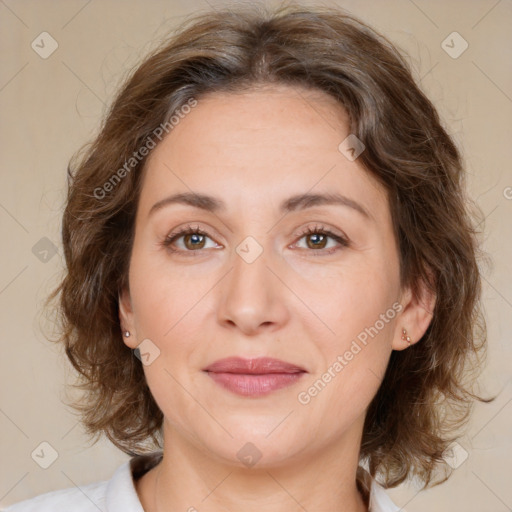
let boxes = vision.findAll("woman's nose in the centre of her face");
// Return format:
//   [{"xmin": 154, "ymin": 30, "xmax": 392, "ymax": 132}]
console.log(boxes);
[{"xmin": 217, "ymin": 239, "xmax": 292, "ymax": 336}]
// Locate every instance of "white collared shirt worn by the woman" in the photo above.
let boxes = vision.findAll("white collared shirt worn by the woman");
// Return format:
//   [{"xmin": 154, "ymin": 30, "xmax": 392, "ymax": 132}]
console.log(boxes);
[{"xmin": 5, "ymin": 452, "xmax": 400, "ymax": 512}]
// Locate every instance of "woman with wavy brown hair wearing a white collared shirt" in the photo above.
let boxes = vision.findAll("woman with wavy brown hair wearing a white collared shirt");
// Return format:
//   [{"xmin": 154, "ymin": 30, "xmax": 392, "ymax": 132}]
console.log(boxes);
[{"xmin": 8, "ymin": 5, "xmax": 485, "ymax": 512}]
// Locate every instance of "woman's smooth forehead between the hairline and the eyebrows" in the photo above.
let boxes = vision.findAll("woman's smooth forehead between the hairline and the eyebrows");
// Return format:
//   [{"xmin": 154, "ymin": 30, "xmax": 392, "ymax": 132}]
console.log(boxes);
[{"xmin": 140, "ymin": 86, "xmax": 382, "ymax": 218}]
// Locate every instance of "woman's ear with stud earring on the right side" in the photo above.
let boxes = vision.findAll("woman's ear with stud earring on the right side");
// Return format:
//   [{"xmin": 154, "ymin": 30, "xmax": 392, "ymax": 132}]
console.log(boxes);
[{"xmin": 392, "ymin": 280, "xmax": 436, "ymax": 350}]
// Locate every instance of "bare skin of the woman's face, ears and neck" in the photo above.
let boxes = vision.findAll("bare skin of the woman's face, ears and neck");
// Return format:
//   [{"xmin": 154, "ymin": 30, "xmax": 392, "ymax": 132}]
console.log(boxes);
[{"xmin": 119, "ymin": 86, "xmax": 434, "ymax": 512}]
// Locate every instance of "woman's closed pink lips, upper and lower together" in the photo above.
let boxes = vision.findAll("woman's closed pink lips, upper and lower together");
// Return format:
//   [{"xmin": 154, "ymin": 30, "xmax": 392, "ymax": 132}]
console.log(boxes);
[{"xmin": 204, "ymin": 357, "xmax": 306, "ymax": 396}]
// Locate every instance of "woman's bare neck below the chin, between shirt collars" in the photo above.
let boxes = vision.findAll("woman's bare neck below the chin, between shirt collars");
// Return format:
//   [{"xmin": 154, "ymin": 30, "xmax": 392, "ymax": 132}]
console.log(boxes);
[{"xmin": 136, "ymin": 420, "xmax": 368, "ymax": 512}]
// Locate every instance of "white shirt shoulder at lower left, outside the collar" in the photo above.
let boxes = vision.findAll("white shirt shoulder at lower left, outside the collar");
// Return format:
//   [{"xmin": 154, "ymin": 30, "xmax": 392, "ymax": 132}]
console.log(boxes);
[{"xmin": 5, "ymin": 481, "xmax": 108, "ymax": 512}]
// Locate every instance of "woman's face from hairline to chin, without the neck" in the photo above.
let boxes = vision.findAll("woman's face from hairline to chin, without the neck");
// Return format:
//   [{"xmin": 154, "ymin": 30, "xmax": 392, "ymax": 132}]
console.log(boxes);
[{"xmin": 121, "ymin": 86, "xmax": 404, "ymax": 466}]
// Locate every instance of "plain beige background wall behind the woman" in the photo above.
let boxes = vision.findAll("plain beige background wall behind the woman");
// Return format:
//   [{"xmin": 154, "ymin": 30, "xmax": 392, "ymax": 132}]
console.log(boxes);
[{"xmin": 0, "ymin": 0, "xmax": 512, "ymax": 512}]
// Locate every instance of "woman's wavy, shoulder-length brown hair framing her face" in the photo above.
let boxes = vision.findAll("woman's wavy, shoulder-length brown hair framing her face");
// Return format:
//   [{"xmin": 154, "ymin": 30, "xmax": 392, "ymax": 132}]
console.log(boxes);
[{"xmin": 49, "ymin": 0, "xmax": 485, "ymax": 487}]
